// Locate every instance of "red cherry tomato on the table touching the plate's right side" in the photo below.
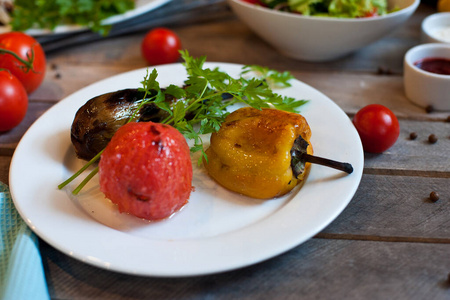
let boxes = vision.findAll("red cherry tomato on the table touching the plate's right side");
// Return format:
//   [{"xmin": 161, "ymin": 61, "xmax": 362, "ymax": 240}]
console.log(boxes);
[{"xmin": 353, "ymin": 104, "xmax": 400, "ymax": 153}]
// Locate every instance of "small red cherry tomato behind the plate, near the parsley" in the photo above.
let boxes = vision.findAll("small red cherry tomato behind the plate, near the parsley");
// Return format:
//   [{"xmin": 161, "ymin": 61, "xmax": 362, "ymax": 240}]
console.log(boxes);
[{"xmin": 141, "ymin": 28, "xmax": 181, "ymax": 65}]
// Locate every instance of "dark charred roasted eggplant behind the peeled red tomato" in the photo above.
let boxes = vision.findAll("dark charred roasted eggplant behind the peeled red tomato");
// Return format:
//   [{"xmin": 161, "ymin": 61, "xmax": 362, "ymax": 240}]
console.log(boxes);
[{"xmin": 71, "ymin": 89, "xmax": 174, "ymax": 160}]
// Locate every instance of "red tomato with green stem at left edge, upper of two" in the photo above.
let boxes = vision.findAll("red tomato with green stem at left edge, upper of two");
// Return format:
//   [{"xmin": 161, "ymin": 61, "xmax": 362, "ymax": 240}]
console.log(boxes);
[{"xmin": 0, "ymin": 32, "xmax": 46, "ymax": 94}]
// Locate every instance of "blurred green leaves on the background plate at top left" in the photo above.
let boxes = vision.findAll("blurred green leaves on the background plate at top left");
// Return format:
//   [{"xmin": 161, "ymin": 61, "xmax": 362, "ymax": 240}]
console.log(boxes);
[{"xmin": 10, "ymin": 0, "xmax": 135, "ymax": 35}]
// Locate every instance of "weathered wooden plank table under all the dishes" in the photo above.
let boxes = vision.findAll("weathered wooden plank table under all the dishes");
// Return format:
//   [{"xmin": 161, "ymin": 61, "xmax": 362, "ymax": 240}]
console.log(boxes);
[{"xmin": 0, "ymin": 4, "xmax": 450, "ymax": 299}]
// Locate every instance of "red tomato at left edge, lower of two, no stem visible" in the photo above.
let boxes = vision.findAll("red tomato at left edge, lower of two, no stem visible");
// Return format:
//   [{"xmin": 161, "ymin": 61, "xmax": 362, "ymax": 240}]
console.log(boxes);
[{"xmin": 0, "ymin": 70, "xmax": 28, "ymax": 132}]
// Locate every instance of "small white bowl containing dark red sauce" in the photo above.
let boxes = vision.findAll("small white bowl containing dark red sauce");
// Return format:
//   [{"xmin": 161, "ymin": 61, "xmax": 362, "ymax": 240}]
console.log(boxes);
[{"xmin": 403, "ymin": 43, "xmax": 450, "ymax": 111}]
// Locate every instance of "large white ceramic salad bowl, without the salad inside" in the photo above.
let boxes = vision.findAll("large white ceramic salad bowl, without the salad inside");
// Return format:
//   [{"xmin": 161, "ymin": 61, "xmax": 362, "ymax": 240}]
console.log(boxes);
[{"xmin": 228, "ymin": 0, "xmax": 420, "ymax": 61}]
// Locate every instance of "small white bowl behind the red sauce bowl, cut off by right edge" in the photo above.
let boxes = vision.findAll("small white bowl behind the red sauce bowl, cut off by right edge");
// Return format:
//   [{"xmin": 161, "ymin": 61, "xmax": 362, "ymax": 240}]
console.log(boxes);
[{"xmin": 421, "ymin": 12, "xmax": 450, "ymax": 44}]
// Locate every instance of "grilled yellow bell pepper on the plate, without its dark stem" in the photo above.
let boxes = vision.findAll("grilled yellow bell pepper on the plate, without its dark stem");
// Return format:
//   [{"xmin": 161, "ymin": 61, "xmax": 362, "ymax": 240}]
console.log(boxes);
[{"xmin": 204, "ymin": 107, "xmax": 313, "ymax": 199}]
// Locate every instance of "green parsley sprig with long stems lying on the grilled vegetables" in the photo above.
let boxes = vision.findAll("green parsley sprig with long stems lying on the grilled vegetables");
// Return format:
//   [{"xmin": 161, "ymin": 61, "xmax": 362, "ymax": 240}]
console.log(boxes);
[{"xmin": 58, "ymin": 50, "xmax": 307, "ymax": 194}]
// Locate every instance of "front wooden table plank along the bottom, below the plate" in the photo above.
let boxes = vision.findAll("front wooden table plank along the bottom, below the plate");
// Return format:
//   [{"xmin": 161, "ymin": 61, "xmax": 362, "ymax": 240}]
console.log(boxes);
[{"xmin": 41, "ymin": 238, "xmax": 450, "ymax": 300}]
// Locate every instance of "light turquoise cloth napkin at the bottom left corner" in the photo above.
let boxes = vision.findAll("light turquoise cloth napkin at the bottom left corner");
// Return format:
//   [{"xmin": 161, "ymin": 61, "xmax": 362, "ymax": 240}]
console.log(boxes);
[{"xmin": 0, "ymin": 182, "xmax": 50, "ymax": 300}]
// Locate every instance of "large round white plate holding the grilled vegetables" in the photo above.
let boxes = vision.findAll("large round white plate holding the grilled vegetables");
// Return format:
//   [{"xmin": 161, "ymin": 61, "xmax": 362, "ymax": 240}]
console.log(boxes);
[{"xmin": 9, "ymin": 63, "xmax": 363, "ymax": 277}]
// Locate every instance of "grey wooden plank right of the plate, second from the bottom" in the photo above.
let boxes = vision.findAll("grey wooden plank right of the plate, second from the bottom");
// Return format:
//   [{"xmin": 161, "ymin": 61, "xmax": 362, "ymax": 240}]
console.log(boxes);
[{"xmin": 320, "ymin": 175, "xmax": 450, "ymax": 239}]
